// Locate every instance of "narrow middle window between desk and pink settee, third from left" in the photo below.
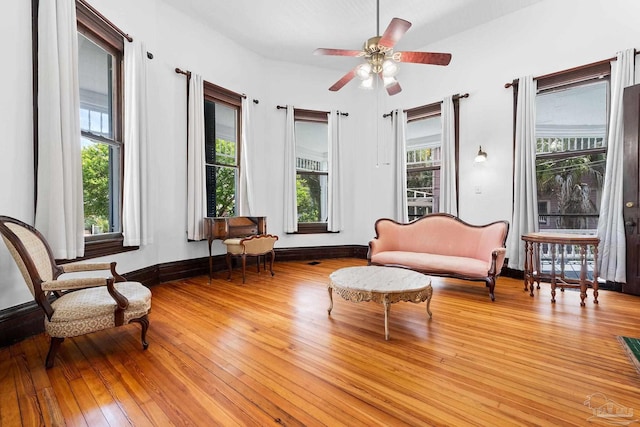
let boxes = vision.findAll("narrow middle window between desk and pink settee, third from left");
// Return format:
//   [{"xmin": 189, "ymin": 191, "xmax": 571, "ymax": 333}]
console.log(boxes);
[{"xmin": 294, "ymin": 109, "xmax": 329, "ymax": 233}]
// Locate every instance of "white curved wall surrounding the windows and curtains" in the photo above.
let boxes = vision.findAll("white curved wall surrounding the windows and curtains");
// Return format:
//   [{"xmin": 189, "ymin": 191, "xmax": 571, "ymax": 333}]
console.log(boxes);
[{"xmin": 0, "ymin": 0, "xmax": 640, "ymax": 309}]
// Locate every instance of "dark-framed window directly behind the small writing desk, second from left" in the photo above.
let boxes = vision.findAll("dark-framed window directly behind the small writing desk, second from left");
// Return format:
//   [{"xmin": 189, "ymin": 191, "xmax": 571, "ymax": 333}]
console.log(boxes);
[{"xmin": 204, "ymin": 82, "xmax": 242, "ymax": 217}]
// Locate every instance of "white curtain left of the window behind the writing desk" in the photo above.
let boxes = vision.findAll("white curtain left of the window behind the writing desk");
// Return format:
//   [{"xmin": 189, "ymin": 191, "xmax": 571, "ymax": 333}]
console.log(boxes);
[{"xmin": 187, "ymin": 73, "xmax": 207, "ymax": 240}]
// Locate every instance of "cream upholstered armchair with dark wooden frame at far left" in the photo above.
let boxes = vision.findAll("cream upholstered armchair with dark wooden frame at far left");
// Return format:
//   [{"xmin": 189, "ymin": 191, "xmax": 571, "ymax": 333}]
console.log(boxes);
[{"xmin": 0, "ymin": 216, "xmax": 151, "ymax": 368}]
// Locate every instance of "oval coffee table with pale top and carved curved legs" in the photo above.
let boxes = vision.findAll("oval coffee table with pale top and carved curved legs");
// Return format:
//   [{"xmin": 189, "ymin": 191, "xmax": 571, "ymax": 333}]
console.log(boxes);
[{"xmin": 327, "ymin": 265, "xmax": 433, "ymax": 340}]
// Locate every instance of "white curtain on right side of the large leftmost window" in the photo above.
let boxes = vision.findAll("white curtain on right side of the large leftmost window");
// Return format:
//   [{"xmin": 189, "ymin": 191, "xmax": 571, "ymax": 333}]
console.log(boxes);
[{"xmin": 122, "ymin": 40, "xmax": 149, "ymax": 246}]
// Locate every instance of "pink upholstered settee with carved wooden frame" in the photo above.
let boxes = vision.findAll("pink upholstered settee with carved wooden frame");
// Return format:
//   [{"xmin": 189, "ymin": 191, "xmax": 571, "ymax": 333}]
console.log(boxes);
[{"xmin": 367, "ymin": 214, "xmax": 509, "ymax": 301}]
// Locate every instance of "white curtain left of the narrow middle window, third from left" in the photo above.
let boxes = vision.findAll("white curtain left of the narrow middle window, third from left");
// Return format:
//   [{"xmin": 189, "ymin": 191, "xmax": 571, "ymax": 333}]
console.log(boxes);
[{"xmin": 284, "ymin": 105, "xmax": 298, "ymax": 233}]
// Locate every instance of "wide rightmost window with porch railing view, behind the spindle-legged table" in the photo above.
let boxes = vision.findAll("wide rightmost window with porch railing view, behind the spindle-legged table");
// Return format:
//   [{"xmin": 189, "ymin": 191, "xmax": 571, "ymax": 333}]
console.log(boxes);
[{"xmin": 536, "ymin": 62, "xmax": 610, "ymax": 232}]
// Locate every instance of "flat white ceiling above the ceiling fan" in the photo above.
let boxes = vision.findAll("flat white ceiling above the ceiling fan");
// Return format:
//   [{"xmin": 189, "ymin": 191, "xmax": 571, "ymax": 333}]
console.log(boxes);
[{"xmin": 164, "ymin": 0, "xmax": 542, "ymax": 70}]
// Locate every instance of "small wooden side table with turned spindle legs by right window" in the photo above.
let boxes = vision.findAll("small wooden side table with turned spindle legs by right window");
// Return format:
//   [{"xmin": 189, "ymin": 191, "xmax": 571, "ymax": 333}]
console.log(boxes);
[{"xmin": 522, "ymin": 233, "xmax": 600, "ymax": 306}]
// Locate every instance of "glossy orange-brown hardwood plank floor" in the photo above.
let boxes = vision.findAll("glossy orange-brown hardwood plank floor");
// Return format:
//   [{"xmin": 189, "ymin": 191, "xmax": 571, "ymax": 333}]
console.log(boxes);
[{"xmin": 0, "ymin": 259, "xmax": 640, "ymax": 427}]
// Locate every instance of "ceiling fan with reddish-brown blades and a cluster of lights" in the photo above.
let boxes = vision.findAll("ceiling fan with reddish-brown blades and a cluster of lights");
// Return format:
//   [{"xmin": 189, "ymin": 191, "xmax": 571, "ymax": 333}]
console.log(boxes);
[{"xmin": 313, "ymin": 0, "xmax": 451, "ymax": 95}]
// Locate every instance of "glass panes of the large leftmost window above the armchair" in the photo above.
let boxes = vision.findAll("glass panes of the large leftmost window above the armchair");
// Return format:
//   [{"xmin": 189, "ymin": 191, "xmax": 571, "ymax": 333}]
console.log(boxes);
[{"xmin": 78, "ymin": 33, "xmax": 122, "ymax": 235}]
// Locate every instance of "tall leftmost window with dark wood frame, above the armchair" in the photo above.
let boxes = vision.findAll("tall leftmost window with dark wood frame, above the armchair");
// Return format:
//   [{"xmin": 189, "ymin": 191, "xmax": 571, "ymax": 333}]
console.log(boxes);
[{"xmin": 76, "ymin": 2, "xmax": 136, "ymax": 258}]
